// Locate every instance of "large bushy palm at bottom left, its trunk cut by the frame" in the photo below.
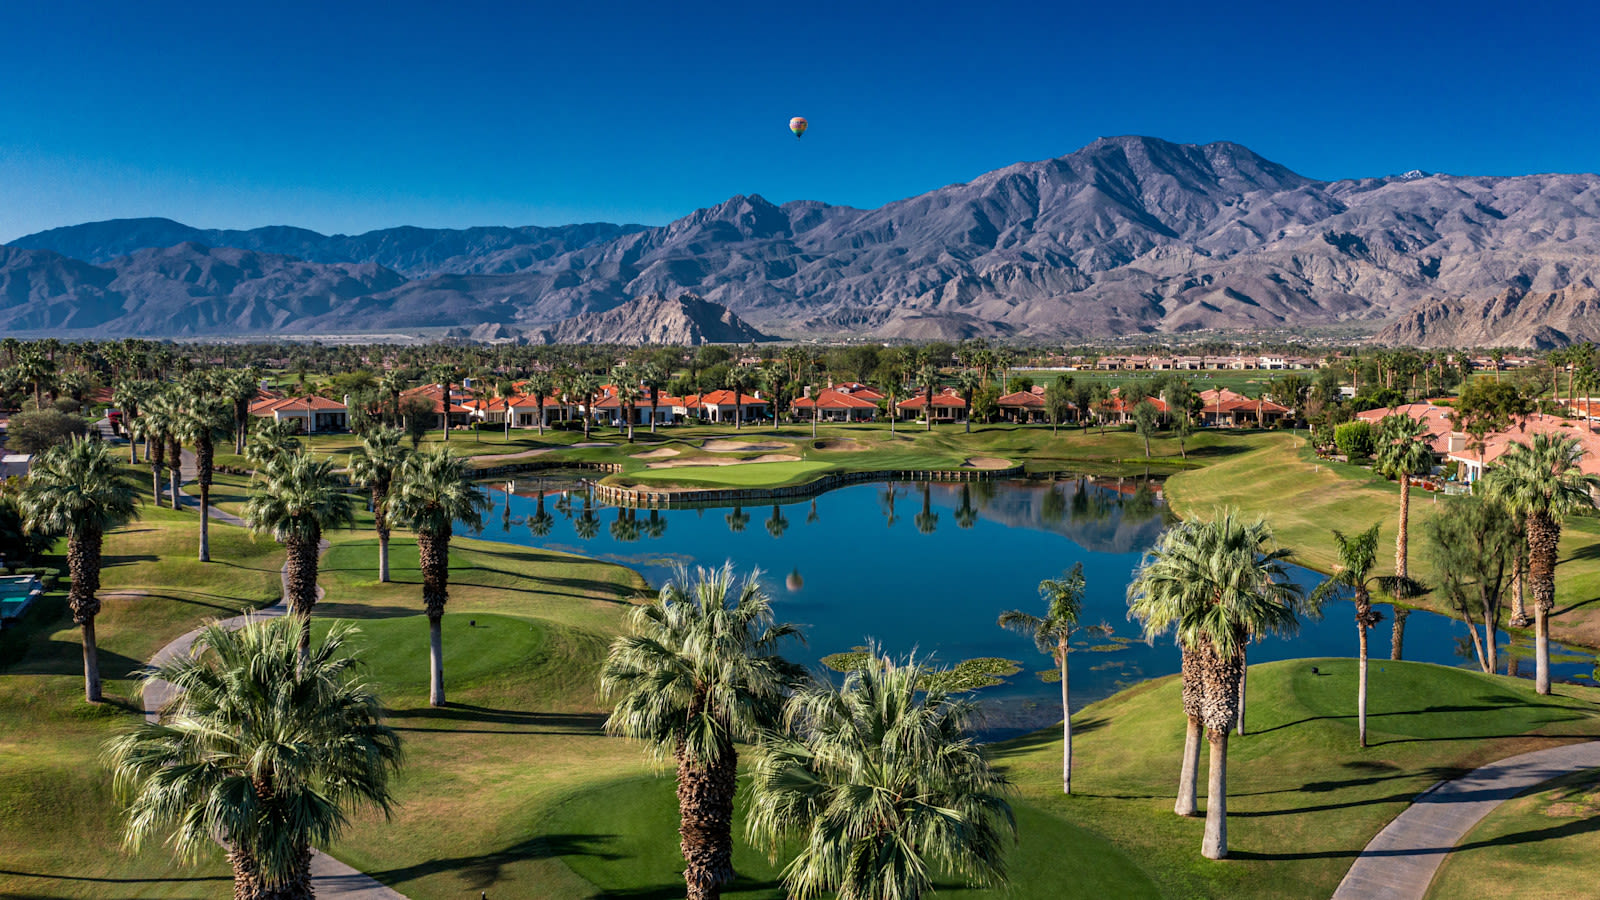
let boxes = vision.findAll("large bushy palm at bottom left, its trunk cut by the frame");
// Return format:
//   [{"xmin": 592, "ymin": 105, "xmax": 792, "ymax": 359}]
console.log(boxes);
[{"xmin": 106, "ymin": 618, "xmax": 402, "ymax": 900}]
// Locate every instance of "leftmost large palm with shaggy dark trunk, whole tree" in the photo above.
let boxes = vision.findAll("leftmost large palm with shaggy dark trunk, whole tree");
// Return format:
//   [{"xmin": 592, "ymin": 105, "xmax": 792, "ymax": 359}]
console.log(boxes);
[{"xmin": 19, "ymin": 437, "xmax": 136, "ymax": 703}]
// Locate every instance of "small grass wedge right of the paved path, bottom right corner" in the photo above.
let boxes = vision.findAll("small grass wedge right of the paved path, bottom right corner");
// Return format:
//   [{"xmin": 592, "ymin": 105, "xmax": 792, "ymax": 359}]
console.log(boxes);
[{"xmin": 1427, "ymin": 769, "xmax": 1600, "ymax": 900}]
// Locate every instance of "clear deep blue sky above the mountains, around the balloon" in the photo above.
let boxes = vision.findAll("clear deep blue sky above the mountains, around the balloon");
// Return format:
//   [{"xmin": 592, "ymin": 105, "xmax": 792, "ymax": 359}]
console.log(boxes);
[{"xmin": 0, "ymin": 0, "xmax": 1600, "ymax": 240}]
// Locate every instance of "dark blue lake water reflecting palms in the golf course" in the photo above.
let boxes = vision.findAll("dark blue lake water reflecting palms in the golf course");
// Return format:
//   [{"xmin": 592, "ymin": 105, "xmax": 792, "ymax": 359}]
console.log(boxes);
[{"xmin": 461, "ymin": 477, "xmax": 1594, "ymax": 737}]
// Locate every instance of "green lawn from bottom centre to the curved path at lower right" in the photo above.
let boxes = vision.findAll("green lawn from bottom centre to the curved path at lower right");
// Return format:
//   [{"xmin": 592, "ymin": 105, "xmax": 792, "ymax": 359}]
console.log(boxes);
[{"xmin": 544, "ymin": 650, "xmax": 1600, "ymax": 900}]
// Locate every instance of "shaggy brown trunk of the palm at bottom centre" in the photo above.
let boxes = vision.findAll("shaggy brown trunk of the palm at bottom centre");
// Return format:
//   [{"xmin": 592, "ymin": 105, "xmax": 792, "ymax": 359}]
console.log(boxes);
[{"xmin": 677, "ymin": 733, "xmax": 739, "ymax": 900}]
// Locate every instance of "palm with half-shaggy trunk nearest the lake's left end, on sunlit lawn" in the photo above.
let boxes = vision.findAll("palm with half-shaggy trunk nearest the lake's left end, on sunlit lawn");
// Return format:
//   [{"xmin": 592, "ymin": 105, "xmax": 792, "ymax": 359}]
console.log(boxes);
[{"xmin": 390, "ymin": 448, "xmax": 490, "ymax": 706}]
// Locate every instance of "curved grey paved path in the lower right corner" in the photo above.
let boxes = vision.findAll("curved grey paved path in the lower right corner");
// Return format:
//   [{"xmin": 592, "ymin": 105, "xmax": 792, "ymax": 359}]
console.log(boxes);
[{"xmin": 1333, "ymin": 741, "xmax": 1600, "ymax": 900}]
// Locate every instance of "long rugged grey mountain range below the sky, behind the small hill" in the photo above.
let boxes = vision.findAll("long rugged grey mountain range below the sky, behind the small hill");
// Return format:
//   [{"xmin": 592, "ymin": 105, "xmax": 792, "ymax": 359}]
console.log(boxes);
[{"xmin": 0, "ymin": 136, "xmax": 1600, "ymax": 346}]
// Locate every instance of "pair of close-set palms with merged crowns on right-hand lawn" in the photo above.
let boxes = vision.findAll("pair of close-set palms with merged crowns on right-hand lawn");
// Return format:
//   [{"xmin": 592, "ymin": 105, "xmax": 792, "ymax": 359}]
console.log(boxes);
[{"xmin": 1128, "ymin": 509, "xmax": 1302, "ymax": 860}]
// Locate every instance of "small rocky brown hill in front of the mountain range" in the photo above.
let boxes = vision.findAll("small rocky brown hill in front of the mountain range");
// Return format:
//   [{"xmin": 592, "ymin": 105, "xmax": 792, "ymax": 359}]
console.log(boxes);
[{"xmin": 550, "ymin": 295, "xmax": 771, "ymax": 346}]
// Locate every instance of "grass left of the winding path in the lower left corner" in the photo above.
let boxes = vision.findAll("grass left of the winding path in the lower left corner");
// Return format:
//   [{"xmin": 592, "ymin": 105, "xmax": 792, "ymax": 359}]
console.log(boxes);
[{"xmin": 0, "ymin": 508, "xmax": 283, "ymax": 898}]
